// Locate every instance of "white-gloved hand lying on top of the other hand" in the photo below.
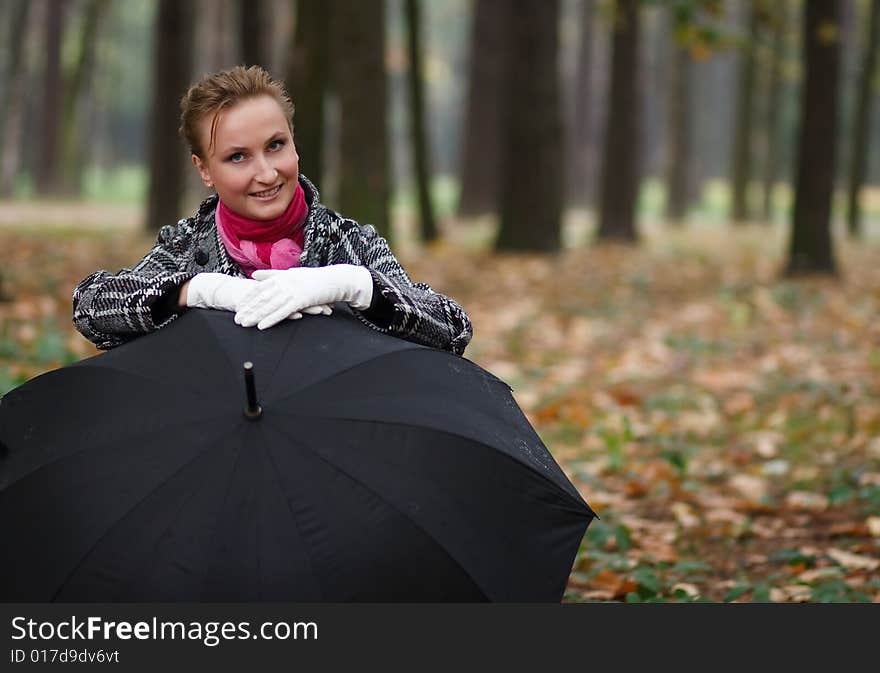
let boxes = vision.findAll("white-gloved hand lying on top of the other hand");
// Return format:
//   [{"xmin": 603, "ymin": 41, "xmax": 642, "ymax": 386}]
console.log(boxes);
[{"xmin": 235, "ymin": 264, "xmax": 373, "ymax": 329}]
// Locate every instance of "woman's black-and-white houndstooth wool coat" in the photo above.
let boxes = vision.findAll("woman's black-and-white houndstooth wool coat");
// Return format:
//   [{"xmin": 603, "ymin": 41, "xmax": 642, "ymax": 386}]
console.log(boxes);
[{"xmin": 73, "ymin": 176, "xmax": 472, "ymax": 355}]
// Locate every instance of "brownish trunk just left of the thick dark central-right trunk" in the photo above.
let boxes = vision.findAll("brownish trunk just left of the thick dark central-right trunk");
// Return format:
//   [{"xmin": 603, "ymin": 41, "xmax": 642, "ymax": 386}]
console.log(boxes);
[{"xmin": 458, "ymin": 0, "xmax": 511, "ymax": 216}]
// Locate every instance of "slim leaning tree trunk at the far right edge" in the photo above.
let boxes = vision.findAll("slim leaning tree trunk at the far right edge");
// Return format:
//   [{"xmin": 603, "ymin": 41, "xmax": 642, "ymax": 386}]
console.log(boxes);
[{"xmin": 847, "ymin": 0, "xmax": 880, "ymax": 236}]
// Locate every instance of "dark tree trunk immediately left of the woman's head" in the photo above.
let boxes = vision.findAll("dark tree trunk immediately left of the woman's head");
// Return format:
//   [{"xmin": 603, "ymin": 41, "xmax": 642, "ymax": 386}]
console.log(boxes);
[{"xmin": 146, "ymin": 0, "xmax": 195, "ymax": 231}]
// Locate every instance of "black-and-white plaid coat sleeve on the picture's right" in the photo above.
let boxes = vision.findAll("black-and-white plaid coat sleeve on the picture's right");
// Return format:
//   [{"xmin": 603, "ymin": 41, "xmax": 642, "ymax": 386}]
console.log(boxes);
[{"xmin": 328, "ymin": 220, "xmax": 473, "ymax": 355}]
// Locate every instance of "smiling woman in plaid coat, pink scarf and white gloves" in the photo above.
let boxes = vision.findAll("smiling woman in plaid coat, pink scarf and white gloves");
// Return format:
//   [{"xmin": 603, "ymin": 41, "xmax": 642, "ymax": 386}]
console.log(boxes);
[{"xmin": 73, "ymin": 66, "xmax": 472, "ymax": 355}]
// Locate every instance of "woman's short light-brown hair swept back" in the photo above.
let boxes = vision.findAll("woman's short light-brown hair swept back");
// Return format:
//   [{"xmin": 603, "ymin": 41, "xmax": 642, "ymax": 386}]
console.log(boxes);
[{"xmin": 178, "ymin": 65, "xmax": 293, "ymax": 159}]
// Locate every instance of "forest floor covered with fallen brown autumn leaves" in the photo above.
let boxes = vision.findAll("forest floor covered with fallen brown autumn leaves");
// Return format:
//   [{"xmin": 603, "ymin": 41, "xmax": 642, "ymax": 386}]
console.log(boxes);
[{"xmin": 0, "ymin": 213, "xmax": 880, "ymax": 602}]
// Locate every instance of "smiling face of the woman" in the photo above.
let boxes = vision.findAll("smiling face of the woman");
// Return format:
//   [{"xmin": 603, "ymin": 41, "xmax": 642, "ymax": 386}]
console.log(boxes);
[{"xmin": 192, "ymin": 96, "xmax": 299, "ymax": 220}]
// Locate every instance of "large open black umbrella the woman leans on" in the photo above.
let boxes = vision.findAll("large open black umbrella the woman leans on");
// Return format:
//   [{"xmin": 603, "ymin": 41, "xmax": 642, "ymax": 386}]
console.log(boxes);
[{"xmin": 0, "ymin": 310, "xmax": 594, "ymax": 602}]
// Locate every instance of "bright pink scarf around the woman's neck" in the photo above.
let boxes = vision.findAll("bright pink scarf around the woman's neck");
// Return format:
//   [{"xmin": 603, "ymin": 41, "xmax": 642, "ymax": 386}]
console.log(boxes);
[{"xmin": 214, "ymin": 184, "xmax": 309, "ymax": 278}]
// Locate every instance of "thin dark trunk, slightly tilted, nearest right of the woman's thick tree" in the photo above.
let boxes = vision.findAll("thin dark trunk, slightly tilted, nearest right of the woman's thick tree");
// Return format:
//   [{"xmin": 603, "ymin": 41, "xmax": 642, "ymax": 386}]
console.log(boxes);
[{"xmin": 406, "ymin": 0, "xmax": 437, "ymax": 242}]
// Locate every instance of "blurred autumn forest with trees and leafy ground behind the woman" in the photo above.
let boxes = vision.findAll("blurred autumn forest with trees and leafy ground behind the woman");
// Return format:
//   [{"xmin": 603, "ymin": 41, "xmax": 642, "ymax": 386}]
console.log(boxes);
[{"xmin": 0, "ymin": 0, "xmax": 880, "ymax": 602}]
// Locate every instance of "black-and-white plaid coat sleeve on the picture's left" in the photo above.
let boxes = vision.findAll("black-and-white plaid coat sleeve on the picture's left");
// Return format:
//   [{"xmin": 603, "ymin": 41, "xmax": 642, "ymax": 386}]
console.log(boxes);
[{"xmin": 73, "ymin": 221, "xmax": 195, "ymax": 350}]
